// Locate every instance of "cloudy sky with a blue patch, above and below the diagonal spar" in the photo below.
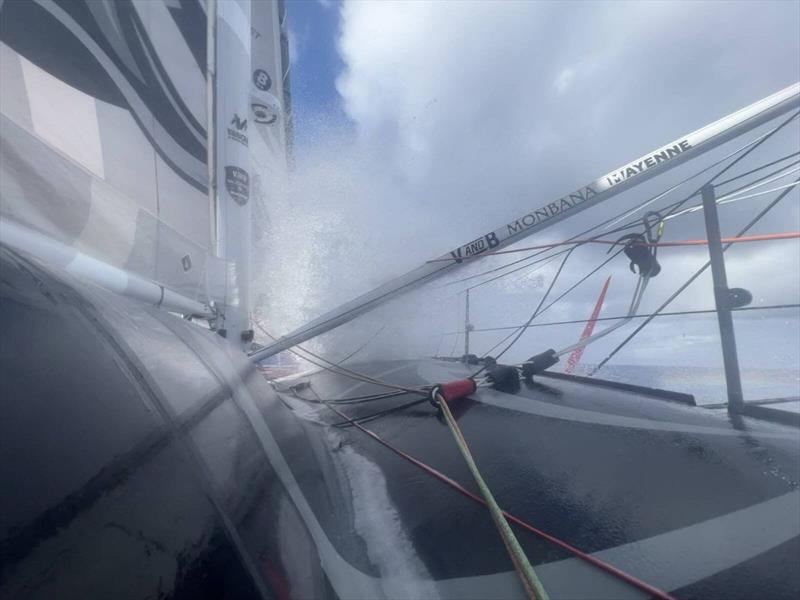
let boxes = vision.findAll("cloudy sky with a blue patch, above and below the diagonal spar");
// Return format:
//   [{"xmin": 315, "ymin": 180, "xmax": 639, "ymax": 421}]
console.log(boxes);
[{"xmin": 263, "ymin": 0, "xmax": 800, "ymax": 390}]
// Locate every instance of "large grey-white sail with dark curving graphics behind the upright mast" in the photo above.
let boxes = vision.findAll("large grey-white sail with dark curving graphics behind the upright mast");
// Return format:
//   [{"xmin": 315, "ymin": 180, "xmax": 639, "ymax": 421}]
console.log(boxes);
[{"xmin": 0, "ymin": 0, "xmax": 289, "ymax": 338}]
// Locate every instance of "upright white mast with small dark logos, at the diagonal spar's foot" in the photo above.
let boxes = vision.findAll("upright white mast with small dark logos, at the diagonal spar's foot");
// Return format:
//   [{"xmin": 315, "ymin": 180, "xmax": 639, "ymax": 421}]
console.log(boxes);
[{"xmin": 214, "ymin": 0, "xmax": 253, "ymax": 347}]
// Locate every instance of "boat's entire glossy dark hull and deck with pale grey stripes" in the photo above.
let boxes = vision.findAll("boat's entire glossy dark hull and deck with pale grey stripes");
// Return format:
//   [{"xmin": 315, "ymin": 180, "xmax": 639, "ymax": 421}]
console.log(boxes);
[{"xmin": 0, "ymin": 250, "xmax": 800, "ymax": 599}]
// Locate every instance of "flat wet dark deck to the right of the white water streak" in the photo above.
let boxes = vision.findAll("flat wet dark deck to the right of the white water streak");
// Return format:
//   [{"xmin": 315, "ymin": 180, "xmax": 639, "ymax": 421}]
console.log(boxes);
[{"xmin": 268, "ymin": 360, "xmax": 800, "ymax": 597}]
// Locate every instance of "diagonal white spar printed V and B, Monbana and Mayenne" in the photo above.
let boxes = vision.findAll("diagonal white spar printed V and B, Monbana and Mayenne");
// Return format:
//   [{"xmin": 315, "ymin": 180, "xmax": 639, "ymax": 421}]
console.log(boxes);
[{"xmin": 251, "ymin": 83, "xmax": 800, "ymax": 360}]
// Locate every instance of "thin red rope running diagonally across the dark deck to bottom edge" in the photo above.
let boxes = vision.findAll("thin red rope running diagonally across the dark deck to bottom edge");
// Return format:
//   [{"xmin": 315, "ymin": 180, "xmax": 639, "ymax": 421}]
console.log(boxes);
[{"xmin": 327, "ymin": 405, "xmax": 674, "ymax": 600}]
